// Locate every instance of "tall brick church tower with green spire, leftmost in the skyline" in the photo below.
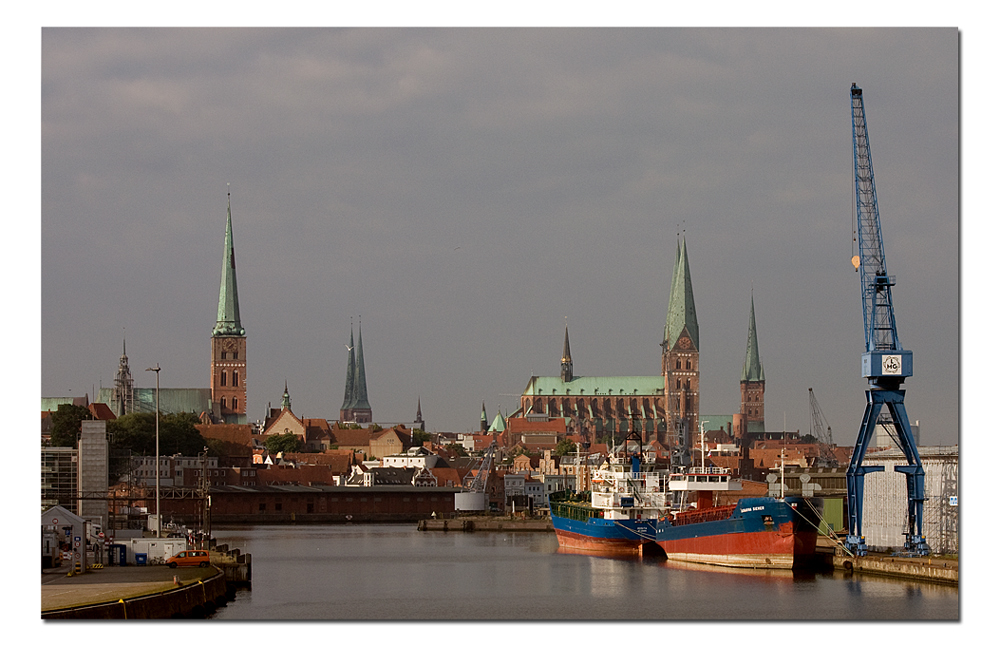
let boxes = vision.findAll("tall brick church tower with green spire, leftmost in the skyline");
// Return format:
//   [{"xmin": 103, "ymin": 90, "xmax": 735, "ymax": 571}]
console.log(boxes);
[{"xmin": 212, "ymin": 194, "xmax": 247, "ymax": 424}]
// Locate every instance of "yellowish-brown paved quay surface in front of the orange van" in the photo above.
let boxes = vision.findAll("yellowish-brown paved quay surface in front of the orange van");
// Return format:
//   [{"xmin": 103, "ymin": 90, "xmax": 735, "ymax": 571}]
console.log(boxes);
[{"xmin": 42, "ymin": 565, "xmax": 219, "ymax": 612}]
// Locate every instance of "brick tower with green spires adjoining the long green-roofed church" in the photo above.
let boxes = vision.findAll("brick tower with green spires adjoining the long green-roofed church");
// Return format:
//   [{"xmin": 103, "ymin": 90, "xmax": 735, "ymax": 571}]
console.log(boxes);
[{"xmin": 661, "ymin": 240, "xmax": 701, "ymax": 460}]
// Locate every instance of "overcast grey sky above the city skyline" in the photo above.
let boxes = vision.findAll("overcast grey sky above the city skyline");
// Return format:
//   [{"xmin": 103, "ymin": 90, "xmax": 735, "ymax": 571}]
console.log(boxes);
[{"xmin": 40, "ymin": 22, "xmax": 961, "ymax": 445}]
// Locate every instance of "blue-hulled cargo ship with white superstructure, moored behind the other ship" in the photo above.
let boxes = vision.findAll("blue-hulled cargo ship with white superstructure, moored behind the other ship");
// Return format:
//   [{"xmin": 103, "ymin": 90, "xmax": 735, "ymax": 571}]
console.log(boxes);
[{"xmin": 549, "ymin": 452, "xmax": 670, "ymax": 555}]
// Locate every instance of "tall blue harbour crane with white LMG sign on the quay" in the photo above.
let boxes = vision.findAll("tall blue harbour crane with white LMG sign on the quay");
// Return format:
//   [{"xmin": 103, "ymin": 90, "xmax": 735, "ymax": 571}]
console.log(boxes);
[{"xmin": 846, "ymin": 84, "xmax": 929, "ymax": 556}]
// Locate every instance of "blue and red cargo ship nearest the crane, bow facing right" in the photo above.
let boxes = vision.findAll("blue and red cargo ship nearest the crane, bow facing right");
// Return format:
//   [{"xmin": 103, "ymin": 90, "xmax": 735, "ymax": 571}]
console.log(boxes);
[{"xmin": 656, "ymin": 467, "xmax": 822, "ymax": 569}]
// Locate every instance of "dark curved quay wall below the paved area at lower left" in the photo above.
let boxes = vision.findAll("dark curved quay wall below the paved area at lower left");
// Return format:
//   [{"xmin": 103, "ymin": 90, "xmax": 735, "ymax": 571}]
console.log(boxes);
[{"xmin": 42, "ymin": 572, "xmax": 228, "ymax": 620}]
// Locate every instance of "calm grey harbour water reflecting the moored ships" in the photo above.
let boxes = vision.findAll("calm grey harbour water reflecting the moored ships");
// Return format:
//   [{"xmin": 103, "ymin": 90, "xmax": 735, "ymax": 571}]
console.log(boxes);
[{"xmin": 207, "ymin": 524, "xmax": 959, "ymax": 621}]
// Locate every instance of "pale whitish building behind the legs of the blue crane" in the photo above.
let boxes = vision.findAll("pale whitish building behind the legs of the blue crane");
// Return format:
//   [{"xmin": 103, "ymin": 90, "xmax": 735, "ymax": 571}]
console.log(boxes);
[{"xmin": 861, "ymin": 446, "xmax": 958, "ymax": 554}]
